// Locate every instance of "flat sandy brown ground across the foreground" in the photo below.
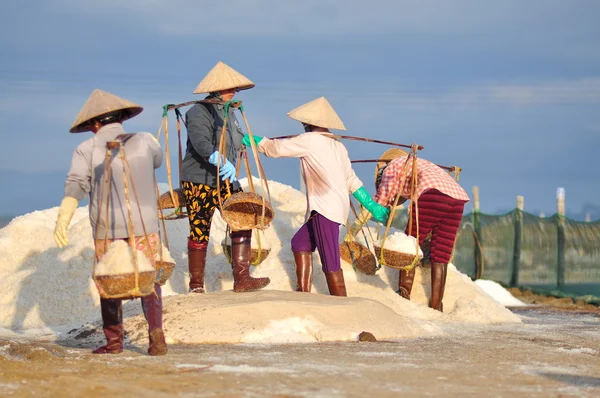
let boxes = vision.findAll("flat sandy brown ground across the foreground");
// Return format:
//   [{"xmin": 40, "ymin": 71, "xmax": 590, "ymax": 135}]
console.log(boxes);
[{"xmin": 0, "ymin": 309, "xmax": 600, "ymax": 398}]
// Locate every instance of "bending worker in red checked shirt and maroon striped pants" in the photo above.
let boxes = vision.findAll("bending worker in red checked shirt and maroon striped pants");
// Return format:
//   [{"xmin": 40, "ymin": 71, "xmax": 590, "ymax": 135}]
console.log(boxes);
[{"xmin": 352, "ymin": 151, "xmax": 469, "ymax": 311}]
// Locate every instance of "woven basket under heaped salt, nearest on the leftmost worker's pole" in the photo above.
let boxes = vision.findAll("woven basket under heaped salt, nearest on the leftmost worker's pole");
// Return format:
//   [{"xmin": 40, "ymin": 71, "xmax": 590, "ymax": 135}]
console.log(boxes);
[{"xmin": 94, "ymin": 271, "xmax": 156, "ymax": 299}]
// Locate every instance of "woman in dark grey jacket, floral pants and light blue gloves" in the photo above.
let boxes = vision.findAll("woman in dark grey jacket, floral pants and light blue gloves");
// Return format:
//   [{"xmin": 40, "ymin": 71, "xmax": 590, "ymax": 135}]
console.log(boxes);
[{"xmin": 181, "ymin": 62, "xmax": 270, "ymax": 293}]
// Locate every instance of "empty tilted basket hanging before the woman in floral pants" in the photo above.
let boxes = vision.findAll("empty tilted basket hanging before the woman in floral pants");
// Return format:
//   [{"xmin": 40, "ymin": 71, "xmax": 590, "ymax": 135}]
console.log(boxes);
[{"xmin": 221, "ymin": 192, "xmax": 274, "ymax": 231}]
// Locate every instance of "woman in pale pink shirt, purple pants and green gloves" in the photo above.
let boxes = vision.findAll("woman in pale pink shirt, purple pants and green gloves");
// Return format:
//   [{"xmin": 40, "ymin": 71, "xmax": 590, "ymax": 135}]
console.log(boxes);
[{"xmin": 242, "ymin": 97, "xmax": 389, "ymax": 296}]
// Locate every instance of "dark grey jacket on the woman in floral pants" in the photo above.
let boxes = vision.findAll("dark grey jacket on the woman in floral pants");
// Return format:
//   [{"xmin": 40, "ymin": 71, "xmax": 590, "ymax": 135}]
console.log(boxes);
[{"xmin": 181, "ymin": 104, "xmax": 244, "ymax": 190}]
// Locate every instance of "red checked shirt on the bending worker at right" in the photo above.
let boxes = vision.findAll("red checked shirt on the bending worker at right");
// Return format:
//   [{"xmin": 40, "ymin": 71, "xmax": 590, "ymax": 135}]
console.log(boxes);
[{"xmin": 373, "ymin": 156, "xmax": 469, "ymax": 206}]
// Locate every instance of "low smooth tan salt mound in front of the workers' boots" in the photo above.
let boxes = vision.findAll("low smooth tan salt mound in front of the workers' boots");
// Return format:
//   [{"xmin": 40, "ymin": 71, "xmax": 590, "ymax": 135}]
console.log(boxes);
[{"xmin": 112, "ymin": 290, "xmax": 443, "ymax": 345}]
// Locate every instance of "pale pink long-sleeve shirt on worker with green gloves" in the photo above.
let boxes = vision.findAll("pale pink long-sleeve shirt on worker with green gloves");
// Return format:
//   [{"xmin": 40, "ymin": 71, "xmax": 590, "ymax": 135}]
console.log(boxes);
[{"xmin": 258, "ymin": 132, "xmax": 363, "ymax": 224}]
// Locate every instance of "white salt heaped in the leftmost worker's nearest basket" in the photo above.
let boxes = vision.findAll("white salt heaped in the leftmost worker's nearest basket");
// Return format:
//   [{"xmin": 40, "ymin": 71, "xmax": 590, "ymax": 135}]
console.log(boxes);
[{"xmin": 96, "ymin": 240, "xmax": 154, "ymax": 275}]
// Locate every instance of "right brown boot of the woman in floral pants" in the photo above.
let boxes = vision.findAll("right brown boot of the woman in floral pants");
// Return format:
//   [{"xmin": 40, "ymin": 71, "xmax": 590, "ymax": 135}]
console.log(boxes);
[{"xmin": 229, "ymin": 231, "xmax": 271, "ymax": 293}]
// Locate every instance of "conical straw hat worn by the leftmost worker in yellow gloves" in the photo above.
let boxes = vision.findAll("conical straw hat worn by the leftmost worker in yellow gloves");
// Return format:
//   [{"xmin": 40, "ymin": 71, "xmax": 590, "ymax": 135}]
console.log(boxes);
[{"xmin": 69, "ymin": 89, "xmax": 144, "ymax": 133}]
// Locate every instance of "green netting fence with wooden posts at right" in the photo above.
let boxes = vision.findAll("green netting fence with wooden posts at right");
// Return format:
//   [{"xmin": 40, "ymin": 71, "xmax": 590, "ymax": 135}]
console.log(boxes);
[{"xmin": 393, "ymin": 209, "xmax": 600, "ymax": 305}]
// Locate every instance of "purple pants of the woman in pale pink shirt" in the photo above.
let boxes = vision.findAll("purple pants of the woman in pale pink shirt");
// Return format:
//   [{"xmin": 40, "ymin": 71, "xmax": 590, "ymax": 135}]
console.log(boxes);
[{"xmin": 292, "ymin": 211, "xmax": 341, "ymax": 272}]
